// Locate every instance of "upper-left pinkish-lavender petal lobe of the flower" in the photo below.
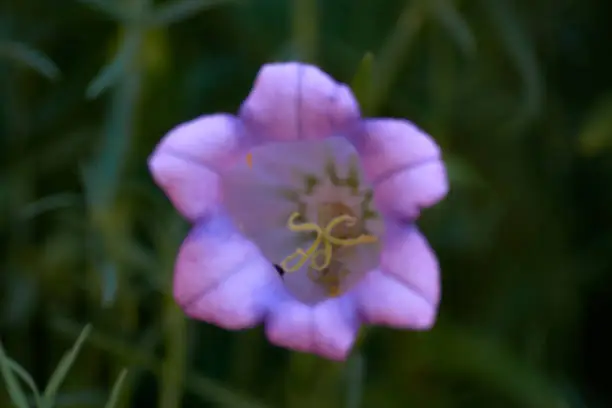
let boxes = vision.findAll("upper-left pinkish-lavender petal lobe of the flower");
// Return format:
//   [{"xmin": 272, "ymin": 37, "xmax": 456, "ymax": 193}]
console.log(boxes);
[{"xmin": 149, "ymin": 115, "xmax": 250, "ymax": 221}]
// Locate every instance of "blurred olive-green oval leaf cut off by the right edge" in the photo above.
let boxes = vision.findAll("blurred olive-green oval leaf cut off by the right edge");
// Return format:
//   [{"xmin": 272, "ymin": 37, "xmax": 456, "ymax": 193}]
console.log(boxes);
[{"xmin": 578, "ymin": 96, "xmax": 612, "ymax": 156}]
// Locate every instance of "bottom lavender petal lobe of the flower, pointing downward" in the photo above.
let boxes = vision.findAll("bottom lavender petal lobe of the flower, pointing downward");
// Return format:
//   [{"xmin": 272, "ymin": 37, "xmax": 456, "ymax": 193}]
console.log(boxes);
[{"xmin": 266, "ymin": 295, "xmax": 360, "ymax": 360}]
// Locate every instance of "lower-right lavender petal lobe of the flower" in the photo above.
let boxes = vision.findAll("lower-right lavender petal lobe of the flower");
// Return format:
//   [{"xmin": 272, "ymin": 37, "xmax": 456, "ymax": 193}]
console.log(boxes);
[{"xmin": 355, "ymin": 225, "xmax": 440, "ymax": 330}]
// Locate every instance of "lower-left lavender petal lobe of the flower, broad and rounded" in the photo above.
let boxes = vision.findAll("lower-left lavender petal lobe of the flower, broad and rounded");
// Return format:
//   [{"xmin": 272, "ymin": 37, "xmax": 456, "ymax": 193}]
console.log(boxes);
[{"xmin": 174, "ymin": 216, "xmax": 281, "ymax": 329}]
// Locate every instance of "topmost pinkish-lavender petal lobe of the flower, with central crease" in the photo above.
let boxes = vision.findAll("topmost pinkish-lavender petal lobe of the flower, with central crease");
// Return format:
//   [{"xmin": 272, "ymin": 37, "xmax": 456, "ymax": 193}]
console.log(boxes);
[{"xmin": 240, "ymin": 62, "xmax": 359, "ymax": 141}]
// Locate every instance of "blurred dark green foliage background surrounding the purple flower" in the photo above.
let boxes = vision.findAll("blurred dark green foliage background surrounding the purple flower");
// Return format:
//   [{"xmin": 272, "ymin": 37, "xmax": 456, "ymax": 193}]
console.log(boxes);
[{"xmin": 0, "ymin": 0, "xmax": 612, "ymax": 408}]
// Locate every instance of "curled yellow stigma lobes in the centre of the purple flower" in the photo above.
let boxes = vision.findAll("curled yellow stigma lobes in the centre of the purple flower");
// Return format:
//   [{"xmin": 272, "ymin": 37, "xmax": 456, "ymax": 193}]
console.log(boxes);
[{"xmin": 280, "ymin": 213, "xmax": 377, "ymax": 272}]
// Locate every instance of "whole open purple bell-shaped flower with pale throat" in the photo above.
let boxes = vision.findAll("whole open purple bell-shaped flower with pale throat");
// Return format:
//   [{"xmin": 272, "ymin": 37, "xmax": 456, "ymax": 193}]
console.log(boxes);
[{"xmin": 149, "ymin": 63, "xmax": 448, "ymax": 360}]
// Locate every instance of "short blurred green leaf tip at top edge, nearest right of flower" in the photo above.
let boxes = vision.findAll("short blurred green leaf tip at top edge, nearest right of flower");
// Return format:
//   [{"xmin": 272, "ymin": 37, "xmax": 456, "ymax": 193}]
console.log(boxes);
[{"xmin": 428, "ymin": 0, "xmax": 476, "ymax": 57}]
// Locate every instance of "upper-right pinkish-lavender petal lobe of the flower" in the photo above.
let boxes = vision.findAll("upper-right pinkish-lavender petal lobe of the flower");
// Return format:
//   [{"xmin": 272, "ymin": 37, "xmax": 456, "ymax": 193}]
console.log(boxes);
[{"xmin": 350, "ymin": 119, "xmax": 448, "ymax": 218}]
